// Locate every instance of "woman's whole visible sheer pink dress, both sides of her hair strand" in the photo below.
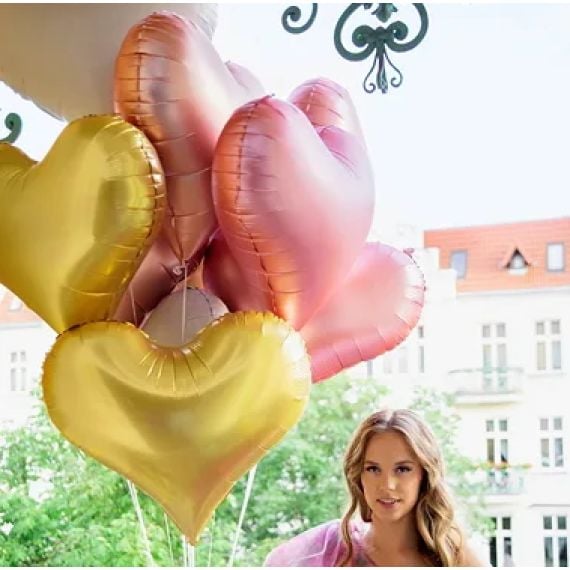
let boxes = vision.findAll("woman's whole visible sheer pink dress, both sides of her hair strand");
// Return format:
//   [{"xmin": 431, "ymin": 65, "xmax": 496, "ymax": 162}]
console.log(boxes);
[{"xmin": 264, "ymin": 520, "xmax": 374, "ymax": 567}]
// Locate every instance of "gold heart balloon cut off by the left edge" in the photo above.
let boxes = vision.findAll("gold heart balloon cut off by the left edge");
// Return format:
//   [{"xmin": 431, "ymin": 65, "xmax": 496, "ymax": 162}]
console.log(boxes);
[{"xmin": 0, "ymin": 116, "xmax": 164, "ymax": 332}]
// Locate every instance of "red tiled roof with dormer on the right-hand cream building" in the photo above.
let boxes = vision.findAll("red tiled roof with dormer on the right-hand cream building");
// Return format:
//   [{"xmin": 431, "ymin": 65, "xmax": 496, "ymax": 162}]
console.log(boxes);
[{"xmin": 424, "ymin": 218, "xmax": 570, "ymax": 293}]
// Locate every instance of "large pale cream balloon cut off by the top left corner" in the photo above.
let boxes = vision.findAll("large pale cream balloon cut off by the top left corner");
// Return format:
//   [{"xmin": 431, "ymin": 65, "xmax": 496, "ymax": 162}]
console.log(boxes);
[{"xmin": 0, "ymin": 2, "xmax": 217, "ymax": 121}]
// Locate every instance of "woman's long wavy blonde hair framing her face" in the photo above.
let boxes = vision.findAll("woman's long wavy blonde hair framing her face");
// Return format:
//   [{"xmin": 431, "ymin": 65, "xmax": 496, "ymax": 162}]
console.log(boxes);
[{"xmin": 338, "ymin": 410, "xmax": 463, "ymax": 566}]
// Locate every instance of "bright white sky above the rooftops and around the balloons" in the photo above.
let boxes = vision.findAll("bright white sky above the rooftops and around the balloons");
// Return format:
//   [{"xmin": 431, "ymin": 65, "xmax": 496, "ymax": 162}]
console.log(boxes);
[{"xmin": 0, "ymin": 3, "xmax": 570, "ymax": 237}]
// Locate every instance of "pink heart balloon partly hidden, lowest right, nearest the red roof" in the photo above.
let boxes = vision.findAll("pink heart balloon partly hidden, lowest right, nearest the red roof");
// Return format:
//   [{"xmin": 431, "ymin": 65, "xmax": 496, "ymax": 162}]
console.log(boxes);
[{"xmin": 301, "ymin": 243, "xmax": 425, "ymax": 382}]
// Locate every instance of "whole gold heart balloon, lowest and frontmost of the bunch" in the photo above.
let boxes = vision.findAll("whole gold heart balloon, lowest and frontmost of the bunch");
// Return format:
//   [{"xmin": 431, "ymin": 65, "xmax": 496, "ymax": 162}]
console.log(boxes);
[{"xmin": 43, "ymin": 313, "xmax": 311, "ymax": 544}]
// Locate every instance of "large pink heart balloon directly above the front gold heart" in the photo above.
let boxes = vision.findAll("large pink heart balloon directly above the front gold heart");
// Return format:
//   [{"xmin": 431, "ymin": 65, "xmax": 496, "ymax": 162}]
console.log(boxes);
[{"xmin": 205, "ymin": 80, "xmax": 374, "ymax": 330}]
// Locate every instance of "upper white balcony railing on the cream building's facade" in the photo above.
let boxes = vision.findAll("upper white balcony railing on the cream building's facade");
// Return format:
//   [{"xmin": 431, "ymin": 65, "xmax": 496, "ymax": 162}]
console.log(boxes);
[{"xmin": 448, "ymin": 368, "xmax": 524, "ymax": 396}]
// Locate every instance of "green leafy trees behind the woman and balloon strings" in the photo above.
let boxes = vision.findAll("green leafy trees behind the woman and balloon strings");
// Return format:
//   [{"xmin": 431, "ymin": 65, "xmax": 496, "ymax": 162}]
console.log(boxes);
[{"xmin": 0, "ymin": 376, "xmax": 486, "ymax": 566}]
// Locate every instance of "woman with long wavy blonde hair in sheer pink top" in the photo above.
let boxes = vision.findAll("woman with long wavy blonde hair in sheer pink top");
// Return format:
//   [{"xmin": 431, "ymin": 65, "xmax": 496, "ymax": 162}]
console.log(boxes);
[{"xmin": 265, "ymin": 410, "xmax": 482, "ymax": 566}]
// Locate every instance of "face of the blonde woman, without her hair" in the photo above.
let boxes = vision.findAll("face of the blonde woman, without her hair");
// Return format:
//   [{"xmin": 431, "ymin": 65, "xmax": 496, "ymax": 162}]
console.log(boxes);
[{"xmin": 360, "ymin": 431, "xmax": 423, "ymax": 522}]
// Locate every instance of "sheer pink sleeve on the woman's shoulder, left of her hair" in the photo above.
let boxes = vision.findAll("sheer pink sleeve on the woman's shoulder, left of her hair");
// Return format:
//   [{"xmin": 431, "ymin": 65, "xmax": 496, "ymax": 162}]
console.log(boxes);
[{"xmin": 264, "ymin": 520, "xmax": 346, "ymax": 567}]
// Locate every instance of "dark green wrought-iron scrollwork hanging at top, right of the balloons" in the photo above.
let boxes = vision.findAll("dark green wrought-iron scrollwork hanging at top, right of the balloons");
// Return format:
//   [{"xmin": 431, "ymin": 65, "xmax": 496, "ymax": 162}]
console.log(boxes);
[{"xmin": 281, "ymin": 4, "xmax": 428, "ymax": 93}]
